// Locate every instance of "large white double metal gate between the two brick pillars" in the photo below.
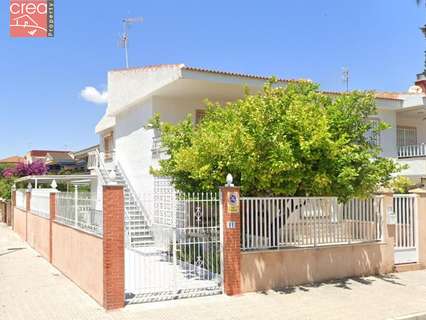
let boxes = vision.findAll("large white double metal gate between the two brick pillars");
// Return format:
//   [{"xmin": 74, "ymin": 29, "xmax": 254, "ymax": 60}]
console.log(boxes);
[{"xmin": 125, "ymin": 187, "xmax": 222, "ymax": 303}]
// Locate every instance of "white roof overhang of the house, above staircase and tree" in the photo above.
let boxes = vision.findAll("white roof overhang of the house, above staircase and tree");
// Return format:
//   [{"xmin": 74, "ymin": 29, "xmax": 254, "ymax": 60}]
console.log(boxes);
[{"xmin": 106, "ymin": 64, "xmax": 298, "ymax": 116}]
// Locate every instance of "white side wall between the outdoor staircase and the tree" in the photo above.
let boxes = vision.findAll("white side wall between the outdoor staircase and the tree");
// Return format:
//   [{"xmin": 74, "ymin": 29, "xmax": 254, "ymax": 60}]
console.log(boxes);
[{"xmin": 114, "ymin": 99, "xmax": 154, "ymax": 197}]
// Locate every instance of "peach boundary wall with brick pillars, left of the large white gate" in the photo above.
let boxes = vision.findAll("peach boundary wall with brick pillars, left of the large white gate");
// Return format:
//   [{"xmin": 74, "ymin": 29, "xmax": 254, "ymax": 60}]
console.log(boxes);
[{"xmin": 11, "ymin": 185, "xmax": 125, "ymax": 310}]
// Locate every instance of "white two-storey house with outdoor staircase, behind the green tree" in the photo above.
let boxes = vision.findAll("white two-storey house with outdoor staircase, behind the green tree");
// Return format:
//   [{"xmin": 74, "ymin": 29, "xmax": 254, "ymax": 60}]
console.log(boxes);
[{"xmin": 90, "ymin": 64, "xmax": 426, "ymax": 246}]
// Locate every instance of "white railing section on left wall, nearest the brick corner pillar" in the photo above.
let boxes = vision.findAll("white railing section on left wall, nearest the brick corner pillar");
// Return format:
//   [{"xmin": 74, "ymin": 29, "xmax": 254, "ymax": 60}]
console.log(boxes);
[{"xmin": 55, "ymin": 192, "xmax": 103, "ymax": 236}]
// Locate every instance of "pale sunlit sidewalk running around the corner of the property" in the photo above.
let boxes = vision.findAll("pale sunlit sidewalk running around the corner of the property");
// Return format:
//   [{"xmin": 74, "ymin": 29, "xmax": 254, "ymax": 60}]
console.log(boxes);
[{"xmin": 0, "ymin": 224, "xmax": 426, "ymax": 320}]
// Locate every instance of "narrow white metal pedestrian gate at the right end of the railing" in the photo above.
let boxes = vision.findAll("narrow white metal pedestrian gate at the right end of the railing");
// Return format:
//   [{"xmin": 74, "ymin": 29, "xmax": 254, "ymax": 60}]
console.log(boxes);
[{"xmin": 389, "ymin": 194, "xmax": 418, "ymax": 264}]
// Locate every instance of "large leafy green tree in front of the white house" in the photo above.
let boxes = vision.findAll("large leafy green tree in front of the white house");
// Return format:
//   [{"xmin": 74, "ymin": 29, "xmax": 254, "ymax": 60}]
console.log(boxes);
[{"xmin": 150, "ymin": 81, "xmax": 397, "ymax": 200}]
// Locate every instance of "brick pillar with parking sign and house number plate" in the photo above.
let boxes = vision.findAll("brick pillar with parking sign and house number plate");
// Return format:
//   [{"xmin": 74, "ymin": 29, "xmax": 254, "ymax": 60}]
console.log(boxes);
[{"xmin": 220, "ymin": 187, "xmax": 241, "ymax": 296}]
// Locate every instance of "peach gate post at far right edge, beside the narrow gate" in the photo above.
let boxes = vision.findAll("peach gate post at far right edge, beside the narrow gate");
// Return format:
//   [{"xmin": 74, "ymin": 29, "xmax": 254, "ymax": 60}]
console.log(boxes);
[{"xmin": 409, "ymin": 188, "xmax": 426, "ymax": 268}]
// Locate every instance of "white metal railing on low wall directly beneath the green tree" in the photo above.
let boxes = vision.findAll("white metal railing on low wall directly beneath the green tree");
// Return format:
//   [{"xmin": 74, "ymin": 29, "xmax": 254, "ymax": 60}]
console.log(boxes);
[{"xmin": 241, "ymin": 197, "xmax": 383, "ymax": 250}]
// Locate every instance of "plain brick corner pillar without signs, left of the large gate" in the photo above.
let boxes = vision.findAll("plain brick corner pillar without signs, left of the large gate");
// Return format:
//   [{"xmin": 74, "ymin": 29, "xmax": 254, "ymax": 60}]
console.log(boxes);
[{"xmin": 103, "ymin": 185, "xmax": 124, "ymax": 310}]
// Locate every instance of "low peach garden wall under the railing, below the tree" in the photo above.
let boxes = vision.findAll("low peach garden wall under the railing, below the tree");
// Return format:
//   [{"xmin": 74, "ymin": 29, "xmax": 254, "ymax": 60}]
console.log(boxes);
[{"xmin": 241, "ymin": 238, "xmax": 394, "ymax": 292}]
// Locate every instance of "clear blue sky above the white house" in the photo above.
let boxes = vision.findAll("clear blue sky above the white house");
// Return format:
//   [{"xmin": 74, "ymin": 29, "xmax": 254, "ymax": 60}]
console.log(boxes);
[{"xmin": 0, "ymin": 0, "xmax": 426, "ymax": 158}]
